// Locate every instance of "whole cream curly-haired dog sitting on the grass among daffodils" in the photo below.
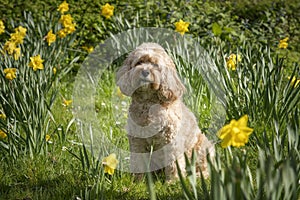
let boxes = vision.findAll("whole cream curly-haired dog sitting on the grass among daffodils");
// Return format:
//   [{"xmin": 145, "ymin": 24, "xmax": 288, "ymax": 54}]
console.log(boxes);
[{"xmin": 117, "ymin": 43, "xmax": 214, "ymax": 179}]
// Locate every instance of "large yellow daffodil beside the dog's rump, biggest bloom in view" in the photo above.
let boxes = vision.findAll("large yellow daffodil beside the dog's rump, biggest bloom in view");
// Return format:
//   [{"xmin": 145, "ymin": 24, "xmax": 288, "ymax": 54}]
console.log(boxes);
[{"xmin": 217, "ymin": 115, "xmax": 253, "ymax": 148}]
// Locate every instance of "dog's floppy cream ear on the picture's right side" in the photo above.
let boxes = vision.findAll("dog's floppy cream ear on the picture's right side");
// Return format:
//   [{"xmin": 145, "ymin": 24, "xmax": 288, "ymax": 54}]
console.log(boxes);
[{"xmin": 160, "ymin": 61, "xmax": 186, "ymax": 101}]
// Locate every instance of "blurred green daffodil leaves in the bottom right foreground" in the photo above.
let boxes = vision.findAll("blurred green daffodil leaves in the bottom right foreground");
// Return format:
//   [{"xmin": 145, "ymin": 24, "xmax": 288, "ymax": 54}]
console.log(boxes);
[{"xmin": 180, "ymin": 115, "xmax": 300, "ymax": 199}]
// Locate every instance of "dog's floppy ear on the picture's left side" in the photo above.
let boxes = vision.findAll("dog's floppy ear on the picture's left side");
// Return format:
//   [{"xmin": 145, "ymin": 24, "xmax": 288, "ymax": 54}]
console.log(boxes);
[{"xmin": 116, "ymin": 58, "xmax": 132, "ymax": 96}]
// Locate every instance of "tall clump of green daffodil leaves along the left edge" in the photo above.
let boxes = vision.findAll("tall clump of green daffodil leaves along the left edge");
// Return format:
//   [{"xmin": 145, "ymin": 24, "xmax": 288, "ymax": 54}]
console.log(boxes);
[{"xmin": 0, "ymin": 13, "xmax": 76, "ymax": 159}]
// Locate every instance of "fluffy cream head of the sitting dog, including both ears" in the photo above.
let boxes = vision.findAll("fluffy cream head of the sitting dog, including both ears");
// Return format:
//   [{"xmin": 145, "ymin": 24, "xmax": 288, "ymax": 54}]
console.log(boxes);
[{"xmin": 117, "ymin": 43, "xmax": 185, "ymax": 101}]
